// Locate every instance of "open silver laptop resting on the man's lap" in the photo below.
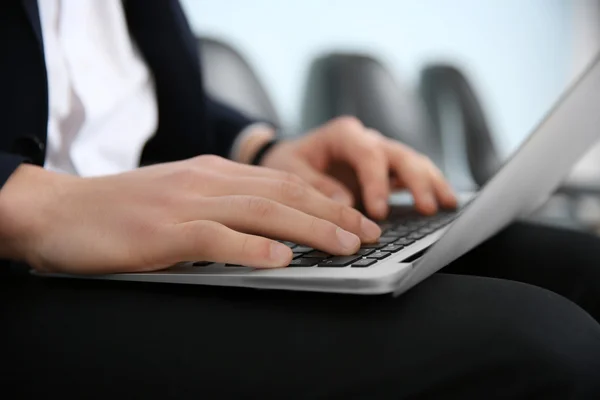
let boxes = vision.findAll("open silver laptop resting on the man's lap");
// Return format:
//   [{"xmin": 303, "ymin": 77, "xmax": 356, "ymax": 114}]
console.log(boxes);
[{"xmin": 35, "ymin": 55, "xmax": 600, "ymax": 295}]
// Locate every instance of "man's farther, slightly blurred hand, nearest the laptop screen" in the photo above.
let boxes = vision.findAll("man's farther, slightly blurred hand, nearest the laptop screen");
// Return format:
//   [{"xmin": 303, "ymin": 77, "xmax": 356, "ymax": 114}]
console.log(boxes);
[{"xmin": 252, "ymin": 117, "xmax": 456, "ymax": 218}]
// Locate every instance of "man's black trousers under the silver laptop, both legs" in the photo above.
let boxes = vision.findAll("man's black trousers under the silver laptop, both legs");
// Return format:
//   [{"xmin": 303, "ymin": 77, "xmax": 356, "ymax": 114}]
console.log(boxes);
[{"xmin": 0, "ymin": 220, "xmax": 600, "ymax": 399}]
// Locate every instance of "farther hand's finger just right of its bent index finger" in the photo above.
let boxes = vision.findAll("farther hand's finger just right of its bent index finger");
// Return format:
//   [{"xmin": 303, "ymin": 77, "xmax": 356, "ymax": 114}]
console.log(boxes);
[{"xmin": 387, "ymin": 143, "xmax": 438, "ymax": 214}]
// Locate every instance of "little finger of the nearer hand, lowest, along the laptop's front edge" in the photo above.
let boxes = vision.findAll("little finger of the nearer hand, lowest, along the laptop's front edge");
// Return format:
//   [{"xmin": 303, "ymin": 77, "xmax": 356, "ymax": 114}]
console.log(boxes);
[{"xmin": 161, "ymin": 221, "xmax": 293, "ymax": 268}]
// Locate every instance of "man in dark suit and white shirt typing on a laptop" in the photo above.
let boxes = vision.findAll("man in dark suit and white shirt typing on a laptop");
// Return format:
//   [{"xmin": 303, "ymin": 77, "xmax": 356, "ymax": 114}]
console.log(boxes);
[{"xmin": 0, "ymin": 0, "xmax": 600, "ymax": 399}]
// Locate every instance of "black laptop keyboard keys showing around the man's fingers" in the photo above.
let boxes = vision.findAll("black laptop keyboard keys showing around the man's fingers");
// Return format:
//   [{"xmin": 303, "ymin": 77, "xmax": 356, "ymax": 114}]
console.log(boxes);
[{"xmin": 193, "ymin": 206, "xmax": 459, "ymax": 268}]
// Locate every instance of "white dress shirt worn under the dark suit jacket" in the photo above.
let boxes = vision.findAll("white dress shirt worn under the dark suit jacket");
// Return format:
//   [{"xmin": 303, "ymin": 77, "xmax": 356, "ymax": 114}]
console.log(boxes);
[{"xmin": 38, "ymin": 0, "xmax": 158, "ymax": 176}]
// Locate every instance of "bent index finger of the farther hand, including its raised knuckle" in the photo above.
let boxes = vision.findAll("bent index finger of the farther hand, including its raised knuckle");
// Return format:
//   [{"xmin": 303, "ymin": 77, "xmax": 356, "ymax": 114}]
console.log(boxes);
[{"xmin": 330, "ymin": 123, "xmax": 390, "ymax": 219}]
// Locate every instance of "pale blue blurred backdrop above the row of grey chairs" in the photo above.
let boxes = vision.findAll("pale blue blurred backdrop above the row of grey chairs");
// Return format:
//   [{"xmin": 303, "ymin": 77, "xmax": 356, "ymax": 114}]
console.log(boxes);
[{"xmin": 182, "ymin": 0, "xmax": 573, "ymax": 154}]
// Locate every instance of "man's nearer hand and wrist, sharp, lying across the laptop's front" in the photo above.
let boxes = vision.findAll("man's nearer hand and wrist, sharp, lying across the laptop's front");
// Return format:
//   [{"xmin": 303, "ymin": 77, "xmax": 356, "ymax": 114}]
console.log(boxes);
[{"xmin": 0, "ymin": 156, "xmax": 381, "ymax": 274}]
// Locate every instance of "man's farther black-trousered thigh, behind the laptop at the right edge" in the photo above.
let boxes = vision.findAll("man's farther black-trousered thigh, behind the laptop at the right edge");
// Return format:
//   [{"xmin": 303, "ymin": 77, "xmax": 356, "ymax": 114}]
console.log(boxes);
[{"xmin": 442, "ymin": 223, "xmax": 600, "ymax": 321}]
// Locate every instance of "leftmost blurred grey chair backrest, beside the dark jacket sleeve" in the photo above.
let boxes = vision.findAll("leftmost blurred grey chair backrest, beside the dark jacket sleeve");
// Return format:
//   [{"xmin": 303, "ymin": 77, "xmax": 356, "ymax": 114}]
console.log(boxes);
[{"xmin": 198, "ymin": 37, "xmax": 280, "ymax": 125}]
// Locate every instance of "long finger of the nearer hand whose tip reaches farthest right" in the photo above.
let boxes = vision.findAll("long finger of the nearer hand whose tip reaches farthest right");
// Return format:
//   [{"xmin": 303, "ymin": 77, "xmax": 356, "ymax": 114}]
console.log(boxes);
[{"xmin": 202, "ymin": 178, "xmax": 381, "ymax": 242}]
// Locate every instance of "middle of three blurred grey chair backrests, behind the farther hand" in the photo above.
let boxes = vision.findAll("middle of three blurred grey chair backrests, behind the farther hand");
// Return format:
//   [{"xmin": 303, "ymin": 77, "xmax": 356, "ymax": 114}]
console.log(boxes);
[{"xmin": 302, "ymin": 53, "xmax": 441, "ymax": 166}]
